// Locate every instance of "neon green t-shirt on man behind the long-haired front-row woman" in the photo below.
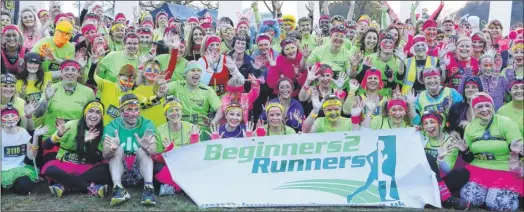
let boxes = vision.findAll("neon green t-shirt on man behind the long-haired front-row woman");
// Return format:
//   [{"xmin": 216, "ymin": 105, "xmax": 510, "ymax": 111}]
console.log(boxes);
[{"xmin": 41, "ymin": 82, "xmax": 95, "ymax": 139}]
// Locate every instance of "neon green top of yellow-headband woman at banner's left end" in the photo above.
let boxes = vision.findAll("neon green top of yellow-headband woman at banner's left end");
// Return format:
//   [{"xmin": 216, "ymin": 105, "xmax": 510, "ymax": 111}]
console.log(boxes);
[{"xmin": 156, "ymin": 121, "xmax": 199, "ymax": 152}]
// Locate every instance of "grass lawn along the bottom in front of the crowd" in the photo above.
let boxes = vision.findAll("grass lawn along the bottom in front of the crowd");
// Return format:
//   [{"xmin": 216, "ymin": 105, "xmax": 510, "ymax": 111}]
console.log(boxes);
[{"xmin": 1, "ymin": 183, "xmax": 446, "ymax": 211}]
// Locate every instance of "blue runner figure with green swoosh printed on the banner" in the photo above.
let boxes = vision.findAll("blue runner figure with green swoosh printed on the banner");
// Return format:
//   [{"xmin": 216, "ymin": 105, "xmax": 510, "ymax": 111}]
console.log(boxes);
[{"xmin": 276, "ymin": 136, "xmax": 403, "ymax": 206}]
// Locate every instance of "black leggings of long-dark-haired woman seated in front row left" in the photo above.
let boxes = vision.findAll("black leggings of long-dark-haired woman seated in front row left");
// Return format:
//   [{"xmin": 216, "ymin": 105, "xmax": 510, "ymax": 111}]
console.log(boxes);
[{"xmin": 45, "ymin": 163, "xmax": 112, "ymax": 192}]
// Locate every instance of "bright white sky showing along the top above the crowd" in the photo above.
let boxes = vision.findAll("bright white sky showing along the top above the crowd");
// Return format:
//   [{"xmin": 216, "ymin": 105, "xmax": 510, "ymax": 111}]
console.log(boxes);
[{"xmin": 57, "ymin": 1, "xmax": 467, "ymax": 16}]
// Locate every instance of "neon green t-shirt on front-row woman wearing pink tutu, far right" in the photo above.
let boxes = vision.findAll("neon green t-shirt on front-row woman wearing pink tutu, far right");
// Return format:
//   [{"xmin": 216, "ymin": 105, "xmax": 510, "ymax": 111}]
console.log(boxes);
[{"xmin": 464, "ymin": 114, "xmax": 522, "ymax": 171}]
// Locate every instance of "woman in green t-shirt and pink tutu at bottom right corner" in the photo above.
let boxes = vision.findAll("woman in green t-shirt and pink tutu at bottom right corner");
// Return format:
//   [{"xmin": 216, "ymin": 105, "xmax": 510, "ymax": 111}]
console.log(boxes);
[{"xmin": 456, "ymin": 92, "xmax": 524, "ymax": 211}]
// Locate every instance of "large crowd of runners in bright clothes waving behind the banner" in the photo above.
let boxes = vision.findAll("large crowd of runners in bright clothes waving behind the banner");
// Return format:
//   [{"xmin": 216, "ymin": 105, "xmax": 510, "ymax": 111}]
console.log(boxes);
[{"xmin": 1, "ymin": 1, "xmax": 524, "ymax": 210}]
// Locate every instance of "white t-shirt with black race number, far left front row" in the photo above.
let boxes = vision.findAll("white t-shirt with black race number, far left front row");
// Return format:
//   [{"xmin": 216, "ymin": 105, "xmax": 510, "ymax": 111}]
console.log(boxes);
[{"xmin": 2, "ymin": 127, "xmax": 31, "ymax": 171}]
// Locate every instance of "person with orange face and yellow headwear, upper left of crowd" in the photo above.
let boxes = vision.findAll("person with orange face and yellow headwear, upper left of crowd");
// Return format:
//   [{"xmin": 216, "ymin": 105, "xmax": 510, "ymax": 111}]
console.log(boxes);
[{"xmin": 31, "ymin": 21, "xmax": 75, "ymax": 73}]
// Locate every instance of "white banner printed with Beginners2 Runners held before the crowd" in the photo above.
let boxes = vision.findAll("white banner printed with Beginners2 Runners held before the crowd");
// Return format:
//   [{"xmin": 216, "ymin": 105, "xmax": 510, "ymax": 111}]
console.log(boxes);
[{"xmin": 164, "ymin": 128, "xmax": 441, "ymax": 208}]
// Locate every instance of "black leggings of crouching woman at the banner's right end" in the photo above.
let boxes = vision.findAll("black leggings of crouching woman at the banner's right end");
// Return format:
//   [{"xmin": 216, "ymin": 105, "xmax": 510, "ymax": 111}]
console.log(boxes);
[{"xmin": 426, "ymin": 154, "xmax": 469, "ymax": 196}]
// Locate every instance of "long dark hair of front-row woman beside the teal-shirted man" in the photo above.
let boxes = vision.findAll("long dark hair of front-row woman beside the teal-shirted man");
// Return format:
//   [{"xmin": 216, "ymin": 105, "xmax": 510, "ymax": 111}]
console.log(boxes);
[{"xmin": 75, "ymin": 100, "xmax": 105, "ymax": 163}]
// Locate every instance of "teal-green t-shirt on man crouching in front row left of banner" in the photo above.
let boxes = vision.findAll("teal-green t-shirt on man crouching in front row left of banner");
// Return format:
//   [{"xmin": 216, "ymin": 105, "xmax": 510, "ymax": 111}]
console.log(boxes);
[{"xmin": 104, "ymin": 116, "xmax": 162, "ymax": 154}]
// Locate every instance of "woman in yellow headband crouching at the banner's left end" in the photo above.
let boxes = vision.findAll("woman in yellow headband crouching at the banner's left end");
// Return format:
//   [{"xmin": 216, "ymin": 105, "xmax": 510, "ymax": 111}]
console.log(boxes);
[{"xmin": 152, "ymin": 96, "xmax": 200, "ymax": 196}]
